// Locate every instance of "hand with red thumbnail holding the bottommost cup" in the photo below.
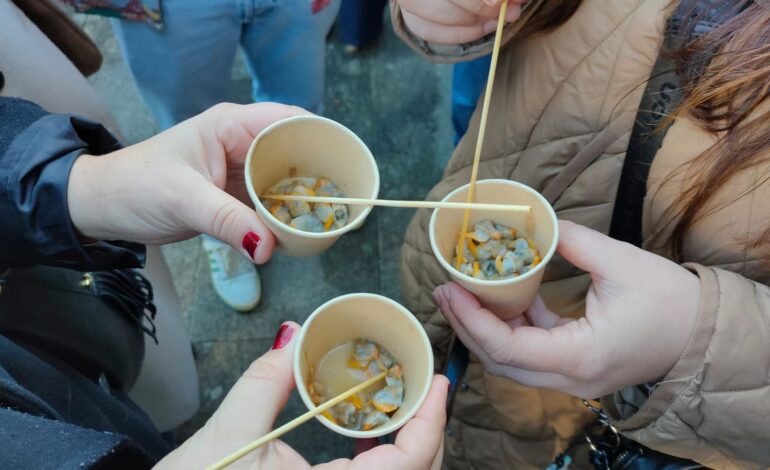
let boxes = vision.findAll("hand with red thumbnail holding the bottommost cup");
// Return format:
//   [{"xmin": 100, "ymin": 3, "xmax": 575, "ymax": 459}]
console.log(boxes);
[{"xmin": 157, "ymin": 322, "xmax": 449, "ymax": 470}]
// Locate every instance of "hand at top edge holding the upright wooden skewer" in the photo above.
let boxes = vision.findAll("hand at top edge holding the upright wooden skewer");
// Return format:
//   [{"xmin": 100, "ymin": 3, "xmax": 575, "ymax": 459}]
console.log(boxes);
[{"xmin": 398, "ymin": 0, "xmax": 527, "ymax": 44}]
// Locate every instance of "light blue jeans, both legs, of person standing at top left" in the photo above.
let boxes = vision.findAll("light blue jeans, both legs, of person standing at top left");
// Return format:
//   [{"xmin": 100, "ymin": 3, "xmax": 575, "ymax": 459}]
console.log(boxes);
[{"xmin": 113, "ymin": 0, "xmax": 340, "ymax": 129}]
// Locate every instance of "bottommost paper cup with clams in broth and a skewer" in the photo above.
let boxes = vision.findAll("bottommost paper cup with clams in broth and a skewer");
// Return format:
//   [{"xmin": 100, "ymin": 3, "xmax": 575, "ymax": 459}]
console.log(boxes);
[{"xmin": 294, "ymin": 294, "xmax": 433, "ymax": 439}]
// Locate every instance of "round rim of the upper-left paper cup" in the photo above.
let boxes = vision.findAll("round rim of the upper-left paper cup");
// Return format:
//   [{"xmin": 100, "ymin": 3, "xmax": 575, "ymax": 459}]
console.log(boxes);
[{"xmin": 243, "ymin": 114, "xmax": 380, "ymax": 240}]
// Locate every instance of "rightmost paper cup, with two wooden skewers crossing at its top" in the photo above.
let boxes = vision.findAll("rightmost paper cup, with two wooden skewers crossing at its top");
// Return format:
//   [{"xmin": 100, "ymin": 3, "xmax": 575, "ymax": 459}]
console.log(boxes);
[{"xmin": 429, "ymin": 180, "xmax": 559, "ymax": 320}]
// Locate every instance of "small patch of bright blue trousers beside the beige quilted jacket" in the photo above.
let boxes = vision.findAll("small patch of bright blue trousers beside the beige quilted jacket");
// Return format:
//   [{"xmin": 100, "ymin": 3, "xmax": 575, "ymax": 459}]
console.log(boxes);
[{"xmin": 452, "ymin": 55, "xmax": 491, "ymax": 145}]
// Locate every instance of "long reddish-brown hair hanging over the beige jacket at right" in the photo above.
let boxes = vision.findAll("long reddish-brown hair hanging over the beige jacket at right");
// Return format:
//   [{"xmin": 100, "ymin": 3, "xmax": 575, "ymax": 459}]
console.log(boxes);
[{"xmin": 660, "ymin": 0, "xmax": 770, "ymax": 261}]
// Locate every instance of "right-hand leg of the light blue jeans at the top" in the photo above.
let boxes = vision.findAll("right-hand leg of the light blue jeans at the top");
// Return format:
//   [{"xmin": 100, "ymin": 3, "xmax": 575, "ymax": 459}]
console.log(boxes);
[{"xmin": 241, "ymin": 0, "xmax": 340, "ymax": 113}]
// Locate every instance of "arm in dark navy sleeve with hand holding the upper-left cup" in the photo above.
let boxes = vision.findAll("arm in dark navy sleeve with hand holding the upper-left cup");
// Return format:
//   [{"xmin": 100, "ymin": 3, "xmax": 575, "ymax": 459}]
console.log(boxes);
[{"xmin": 0, "ymin": 98, "xmax": 305, "ymax": 270}]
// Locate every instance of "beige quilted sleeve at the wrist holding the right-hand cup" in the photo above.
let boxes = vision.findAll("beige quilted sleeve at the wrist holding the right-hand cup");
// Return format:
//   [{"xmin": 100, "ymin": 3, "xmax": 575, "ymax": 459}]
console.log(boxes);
[{"xmin": 604, "ymin": 265, "xmax": 770, "ymax": 469}]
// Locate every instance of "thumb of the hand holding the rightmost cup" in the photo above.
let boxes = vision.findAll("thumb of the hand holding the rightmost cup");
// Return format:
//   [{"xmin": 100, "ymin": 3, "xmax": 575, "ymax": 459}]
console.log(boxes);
[{"xmin": 557, "ymin": 220, "xmax": 636, "ymax": 278}]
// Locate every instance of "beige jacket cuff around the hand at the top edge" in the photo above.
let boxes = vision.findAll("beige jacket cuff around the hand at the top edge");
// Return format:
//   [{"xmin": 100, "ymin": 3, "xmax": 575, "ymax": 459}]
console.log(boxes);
[{"xmin": 390, "ymin": 0, "xmax": 545, "ymax": 63}]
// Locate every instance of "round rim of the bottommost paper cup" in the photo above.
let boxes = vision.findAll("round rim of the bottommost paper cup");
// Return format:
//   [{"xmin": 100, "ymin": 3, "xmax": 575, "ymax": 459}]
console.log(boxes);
[{"xmin": 293, "ymin": 293, "xmax": 434, "ymax": 439}]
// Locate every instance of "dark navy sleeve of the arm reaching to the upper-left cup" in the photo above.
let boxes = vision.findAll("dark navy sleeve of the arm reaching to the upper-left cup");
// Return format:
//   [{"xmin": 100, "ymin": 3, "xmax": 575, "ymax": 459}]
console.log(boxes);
[{"xmin": 0, "ymin": 97, "xmax": 145, "ymax": 271}]
